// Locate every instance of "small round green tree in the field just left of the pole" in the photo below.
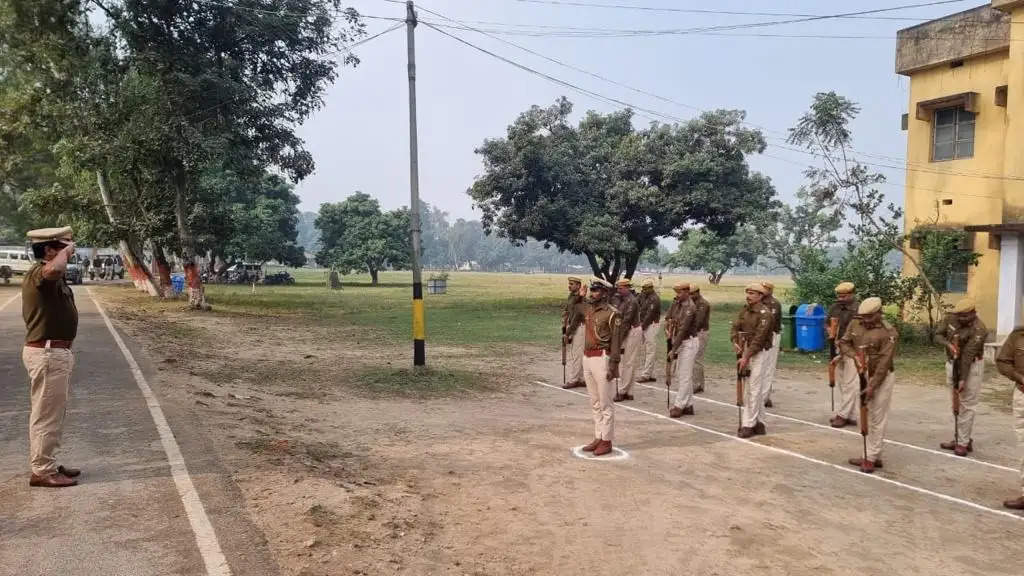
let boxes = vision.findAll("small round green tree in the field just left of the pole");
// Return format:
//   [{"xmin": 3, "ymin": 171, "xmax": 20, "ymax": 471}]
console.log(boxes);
[{"xmin": 316, "ymin": 192, "xmax": 412, "ymax": 286}]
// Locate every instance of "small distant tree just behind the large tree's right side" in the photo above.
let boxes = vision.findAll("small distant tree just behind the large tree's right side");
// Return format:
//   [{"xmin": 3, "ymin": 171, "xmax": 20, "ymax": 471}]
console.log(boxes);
[{"xmin": 669, "ymin": 225, "xmax": 762, "ymax": 286}]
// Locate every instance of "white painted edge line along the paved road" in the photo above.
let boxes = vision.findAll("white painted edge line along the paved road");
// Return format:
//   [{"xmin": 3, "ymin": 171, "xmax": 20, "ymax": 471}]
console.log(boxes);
[{"xmin": 85, "ymin": 288, "xmax": 231, "ymax": 576}]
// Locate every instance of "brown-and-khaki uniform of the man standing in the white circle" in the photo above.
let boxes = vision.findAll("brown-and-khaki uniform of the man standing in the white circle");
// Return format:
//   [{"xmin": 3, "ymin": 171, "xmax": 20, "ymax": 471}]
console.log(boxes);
[{"xmin": 577, "ymin": 300, "xmax": 622, "ymax": 442}]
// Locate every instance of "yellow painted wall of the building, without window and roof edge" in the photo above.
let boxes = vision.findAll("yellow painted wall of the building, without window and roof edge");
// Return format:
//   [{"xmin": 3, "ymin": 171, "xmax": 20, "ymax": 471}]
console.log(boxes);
[{"xmin": 904, "ymin": 49, "xmax": 1007, "ymax": 327}]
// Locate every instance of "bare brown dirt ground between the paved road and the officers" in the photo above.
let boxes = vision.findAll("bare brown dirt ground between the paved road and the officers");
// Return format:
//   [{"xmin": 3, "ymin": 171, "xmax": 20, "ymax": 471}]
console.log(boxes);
[{"xmin": 96, "ymin": 290, "xmax": 1024, "ymax": 576}]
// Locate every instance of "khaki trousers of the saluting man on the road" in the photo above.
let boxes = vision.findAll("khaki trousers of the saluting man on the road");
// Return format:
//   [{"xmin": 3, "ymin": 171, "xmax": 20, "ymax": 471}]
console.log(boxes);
[{"xmin": 22, "ymin": 346, "xmax": 75, "ymax": 476}]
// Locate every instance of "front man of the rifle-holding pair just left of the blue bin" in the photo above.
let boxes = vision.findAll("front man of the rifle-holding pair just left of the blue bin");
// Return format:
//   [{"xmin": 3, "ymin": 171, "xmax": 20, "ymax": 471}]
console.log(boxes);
[{"xmin": 730, "ymin": 282, "xmax": 772, "ymax": 438}]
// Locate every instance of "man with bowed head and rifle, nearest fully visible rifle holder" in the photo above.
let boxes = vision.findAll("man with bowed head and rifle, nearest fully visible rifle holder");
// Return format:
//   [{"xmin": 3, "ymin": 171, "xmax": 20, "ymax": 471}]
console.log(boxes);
[{"xmin": 839, "ymin": 297, "xmax": 898, "ymax": 474}]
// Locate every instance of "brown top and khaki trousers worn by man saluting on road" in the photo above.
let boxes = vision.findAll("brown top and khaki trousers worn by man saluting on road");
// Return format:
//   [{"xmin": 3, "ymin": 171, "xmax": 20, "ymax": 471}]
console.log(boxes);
[{"xmin": 22, "ymin": 262, "xmax": 78, "ymax": 477}]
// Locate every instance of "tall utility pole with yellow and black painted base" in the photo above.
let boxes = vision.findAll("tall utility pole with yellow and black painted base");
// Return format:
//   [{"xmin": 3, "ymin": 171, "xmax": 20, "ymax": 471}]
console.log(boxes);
[{"xmin": 406, "ymin": 0, "xmax": 427, "ymax": 366}]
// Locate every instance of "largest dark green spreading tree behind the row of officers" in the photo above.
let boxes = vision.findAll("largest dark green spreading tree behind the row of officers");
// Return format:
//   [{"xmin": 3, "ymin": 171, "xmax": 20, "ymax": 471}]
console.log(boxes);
[{"xmin": 469, "ymin": 97, "xmax": 774, "ymax": 281}]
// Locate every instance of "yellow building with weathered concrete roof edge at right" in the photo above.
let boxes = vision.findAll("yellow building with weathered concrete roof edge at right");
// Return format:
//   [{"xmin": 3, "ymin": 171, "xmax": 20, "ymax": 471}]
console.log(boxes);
[{"xmin": 896, "ymin": 0, "xmax": 1024, "ymax": 339}]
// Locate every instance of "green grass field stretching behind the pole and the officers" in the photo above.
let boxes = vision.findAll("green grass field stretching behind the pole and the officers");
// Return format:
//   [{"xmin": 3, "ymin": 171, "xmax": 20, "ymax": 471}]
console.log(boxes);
[{"xmin": 110, "ymin": 269, "xmax": 942, "ymax": 379}]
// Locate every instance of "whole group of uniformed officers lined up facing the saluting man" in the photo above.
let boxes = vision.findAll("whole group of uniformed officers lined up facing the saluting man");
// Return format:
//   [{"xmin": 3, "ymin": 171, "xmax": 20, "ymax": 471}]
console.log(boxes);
[{"xmin": 562, "ymin": 277, "xmax": 1024, "ymax": 509}]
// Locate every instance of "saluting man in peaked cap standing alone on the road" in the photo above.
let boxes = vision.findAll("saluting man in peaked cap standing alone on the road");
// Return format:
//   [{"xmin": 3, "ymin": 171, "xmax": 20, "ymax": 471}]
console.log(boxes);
[{"xmin": 22, "ymin": 228, "xmax": 80, "ymax": 488}]
